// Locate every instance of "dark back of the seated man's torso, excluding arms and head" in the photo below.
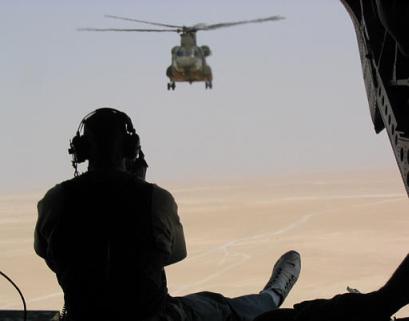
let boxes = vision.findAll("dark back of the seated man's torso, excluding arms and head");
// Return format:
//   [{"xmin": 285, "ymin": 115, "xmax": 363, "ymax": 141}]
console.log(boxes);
[{"xmin": 39, "ymin": 171, "xmax": 167, "ymax": 320}]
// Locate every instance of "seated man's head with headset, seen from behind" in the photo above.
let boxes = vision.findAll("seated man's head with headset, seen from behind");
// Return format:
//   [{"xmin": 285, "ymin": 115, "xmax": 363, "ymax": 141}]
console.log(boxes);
[{"xmin": 69, "ymin": 108, "xmax": 140, "ymax": 169}]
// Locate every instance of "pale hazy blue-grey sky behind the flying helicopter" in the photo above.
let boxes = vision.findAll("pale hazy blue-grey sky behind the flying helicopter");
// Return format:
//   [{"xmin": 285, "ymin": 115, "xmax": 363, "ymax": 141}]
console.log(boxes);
[{"xmin": 0, "ymin": 0, "xmax": 398, "ymax": 191}]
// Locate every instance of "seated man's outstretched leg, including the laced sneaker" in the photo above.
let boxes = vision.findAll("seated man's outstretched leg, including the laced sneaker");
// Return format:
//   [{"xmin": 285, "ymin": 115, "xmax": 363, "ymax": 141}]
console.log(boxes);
[{"xmin": 176, "ymin": 251, "xmax": 301, "ymax": 321}]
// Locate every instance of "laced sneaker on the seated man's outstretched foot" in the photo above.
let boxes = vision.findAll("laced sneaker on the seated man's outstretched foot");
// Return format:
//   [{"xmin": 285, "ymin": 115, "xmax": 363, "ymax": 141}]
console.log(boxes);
[{"xmin": 261, "ymin": 251, "xmax": 301, "ymax": 306}]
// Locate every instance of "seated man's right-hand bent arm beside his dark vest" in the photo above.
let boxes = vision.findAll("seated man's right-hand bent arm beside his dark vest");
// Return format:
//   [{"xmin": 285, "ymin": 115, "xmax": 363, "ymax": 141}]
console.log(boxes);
[{"xmin": 152, "ymin": 185, "xmax": 187, "ymax": 265}]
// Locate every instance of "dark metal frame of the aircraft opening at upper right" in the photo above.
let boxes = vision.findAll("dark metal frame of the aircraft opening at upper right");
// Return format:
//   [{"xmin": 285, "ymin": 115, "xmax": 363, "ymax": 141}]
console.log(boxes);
[{"xmin": 341, "ymin": 0, "xmax": 409, "ymax": 195}]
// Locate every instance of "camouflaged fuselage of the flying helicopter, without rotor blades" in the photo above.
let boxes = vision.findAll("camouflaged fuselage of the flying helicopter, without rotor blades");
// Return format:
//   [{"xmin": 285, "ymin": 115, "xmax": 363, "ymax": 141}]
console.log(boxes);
[{"xmin": 166, "ymin": 32, "xmax": 213, "ymax": 89}]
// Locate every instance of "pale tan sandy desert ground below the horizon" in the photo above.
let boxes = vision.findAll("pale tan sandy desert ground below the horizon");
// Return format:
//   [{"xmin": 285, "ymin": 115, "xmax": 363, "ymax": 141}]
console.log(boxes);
[{"xmin": 0, "ymin": 169, "xmax": 409, "ymax": 316}]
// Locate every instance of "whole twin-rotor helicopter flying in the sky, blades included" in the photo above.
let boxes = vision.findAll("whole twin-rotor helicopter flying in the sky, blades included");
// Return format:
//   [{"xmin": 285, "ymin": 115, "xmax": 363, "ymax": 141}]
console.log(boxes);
[{"xmin": 78, "ymin": 15, "xmax": 284, "ymax": 90}]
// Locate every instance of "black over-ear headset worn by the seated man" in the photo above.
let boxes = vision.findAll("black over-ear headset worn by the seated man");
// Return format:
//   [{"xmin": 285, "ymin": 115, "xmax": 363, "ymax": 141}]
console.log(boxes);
[{"xmin": 68, "ymin": 107, "xmax": 144, "ymax": 176}]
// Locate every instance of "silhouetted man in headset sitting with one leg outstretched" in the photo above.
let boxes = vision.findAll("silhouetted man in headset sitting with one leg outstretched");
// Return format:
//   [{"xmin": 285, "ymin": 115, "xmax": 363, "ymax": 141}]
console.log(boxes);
[{"xmin": 35, "ymin": 108, "xmax": 301, "ymax": 321}]
